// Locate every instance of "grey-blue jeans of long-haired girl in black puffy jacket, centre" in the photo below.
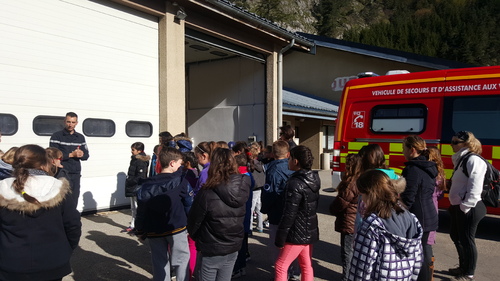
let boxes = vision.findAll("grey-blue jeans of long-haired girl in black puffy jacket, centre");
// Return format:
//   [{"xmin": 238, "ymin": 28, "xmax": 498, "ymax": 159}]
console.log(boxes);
[{"xmin": 195, "ymin": 249, "xmax": 238, "ymax": 281}]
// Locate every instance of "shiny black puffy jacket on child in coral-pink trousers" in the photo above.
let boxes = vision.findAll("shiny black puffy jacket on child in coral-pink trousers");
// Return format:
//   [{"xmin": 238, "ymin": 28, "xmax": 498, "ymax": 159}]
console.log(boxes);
[{"xmin": 275, "ymin": 170, "xmax": 321, "ymax": 245}]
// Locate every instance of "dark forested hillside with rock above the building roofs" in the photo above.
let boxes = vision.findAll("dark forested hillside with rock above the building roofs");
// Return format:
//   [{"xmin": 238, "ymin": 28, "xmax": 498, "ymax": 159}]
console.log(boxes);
[{"xmin": 232, "ymin": 0, "xmax": 500, "ymax": 65}]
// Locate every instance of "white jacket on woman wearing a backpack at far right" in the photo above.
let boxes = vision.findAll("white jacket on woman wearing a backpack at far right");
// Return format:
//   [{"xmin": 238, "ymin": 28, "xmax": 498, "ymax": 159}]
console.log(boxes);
[{"xmin": 449, "ymin": 147, "xmax": 487, "ymax": 213}]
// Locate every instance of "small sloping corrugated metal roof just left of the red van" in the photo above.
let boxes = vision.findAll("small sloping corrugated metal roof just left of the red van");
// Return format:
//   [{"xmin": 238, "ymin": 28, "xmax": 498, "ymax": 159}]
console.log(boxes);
[{"xmin": 283, "ymin": 88, "xmax": 339, "ymax": 120}]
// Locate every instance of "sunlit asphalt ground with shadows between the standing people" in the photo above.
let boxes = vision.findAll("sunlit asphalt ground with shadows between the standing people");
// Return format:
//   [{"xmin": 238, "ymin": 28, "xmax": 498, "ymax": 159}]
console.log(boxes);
[{"xmin": 63, "ymin": 168, "xmax": 500, "ymax": 281}]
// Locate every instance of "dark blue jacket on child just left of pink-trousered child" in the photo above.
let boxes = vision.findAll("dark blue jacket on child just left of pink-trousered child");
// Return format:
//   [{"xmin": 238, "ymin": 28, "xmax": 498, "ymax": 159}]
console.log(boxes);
[{"xmin": 260, "ymin": 158, "xmax": 293, "ymax": 225}]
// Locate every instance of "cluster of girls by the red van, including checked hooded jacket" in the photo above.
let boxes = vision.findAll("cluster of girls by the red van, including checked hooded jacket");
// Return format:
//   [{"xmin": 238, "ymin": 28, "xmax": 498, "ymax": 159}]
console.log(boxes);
[{"xmin": 330, "ymin": 138, "xmax": 445, "ymax": 280}]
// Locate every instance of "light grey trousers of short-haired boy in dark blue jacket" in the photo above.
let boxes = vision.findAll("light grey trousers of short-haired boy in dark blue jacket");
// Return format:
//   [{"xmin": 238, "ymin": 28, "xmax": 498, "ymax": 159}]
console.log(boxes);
[{"xmin": 148, "ymin": 230, "xmax": 189, "ymax": 281}]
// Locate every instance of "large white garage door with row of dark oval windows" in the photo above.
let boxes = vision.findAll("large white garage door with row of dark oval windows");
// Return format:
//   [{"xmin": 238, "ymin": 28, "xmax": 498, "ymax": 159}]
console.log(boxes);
[{"xmin": 0, "ymin": 0, "xmax": 159, "ymax": 209}]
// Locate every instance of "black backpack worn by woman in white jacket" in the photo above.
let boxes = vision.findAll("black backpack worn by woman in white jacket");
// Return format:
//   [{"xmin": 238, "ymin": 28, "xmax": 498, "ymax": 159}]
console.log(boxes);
[{"xmin": 455, "ymin": 152, "xmax": 500, "ymax": 207}]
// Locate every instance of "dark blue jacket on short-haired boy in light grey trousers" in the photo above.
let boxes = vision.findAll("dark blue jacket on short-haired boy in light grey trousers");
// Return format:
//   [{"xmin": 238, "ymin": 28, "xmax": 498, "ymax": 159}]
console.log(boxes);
[{"xmin": 135, "ymin": 169, "xmax": 193, "ymax": 237}]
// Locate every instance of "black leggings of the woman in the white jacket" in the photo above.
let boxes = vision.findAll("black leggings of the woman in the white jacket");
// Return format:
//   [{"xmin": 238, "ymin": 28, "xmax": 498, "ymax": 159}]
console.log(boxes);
[{"xmin": 448, "ymin": 201, "xmax": 486, "ymax": 275}]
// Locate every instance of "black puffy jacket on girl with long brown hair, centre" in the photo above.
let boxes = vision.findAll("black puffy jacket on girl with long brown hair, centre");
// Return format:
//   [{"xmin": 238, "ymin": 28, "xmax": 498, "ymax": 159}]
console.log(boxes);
[{"xmin": 187, "ymin": 174, "xmax": 251, "ymax": 257}]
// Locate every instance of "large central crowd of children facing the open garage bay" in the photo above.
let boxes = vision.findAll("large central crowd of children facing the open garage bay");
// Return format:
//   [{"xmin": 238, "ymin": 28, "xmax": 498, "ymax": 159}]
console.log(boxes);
[{"xmin": 125, "ymin": 133, "xmax": 320, "ymax": 281}]
